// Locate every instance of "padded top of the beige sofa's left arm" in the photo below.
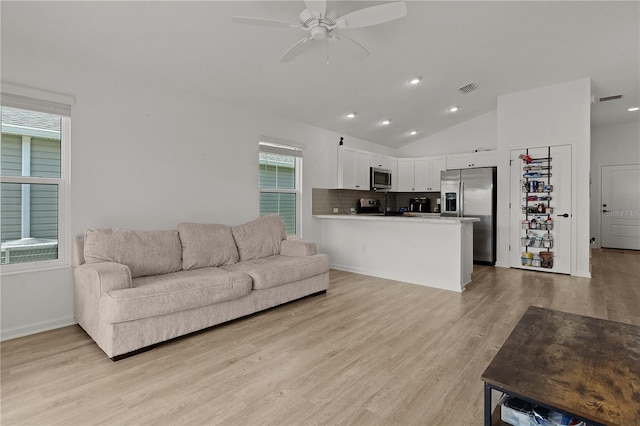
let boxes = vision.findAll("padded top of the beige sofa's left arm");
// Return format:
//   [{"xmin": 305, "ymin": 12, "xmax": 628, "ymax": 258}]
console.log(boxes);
[{"xmin": 73, "ymin": 262, "xmax": 132, "ymax": 296}]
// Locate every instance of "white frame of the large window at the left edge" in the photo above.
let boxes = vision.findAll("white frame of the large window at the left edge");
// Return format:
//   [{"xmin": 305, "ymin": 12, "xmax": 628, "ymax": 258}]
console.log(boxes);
[{"xmin": 0, "ymin": 82, "xmax": 75, "ymax": 275}]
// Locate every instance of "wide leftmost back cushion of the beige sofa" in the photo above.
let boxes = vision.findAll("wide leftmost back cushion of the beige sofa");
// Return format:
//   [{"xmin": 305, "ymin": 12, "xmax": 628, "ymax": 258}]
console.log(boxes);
[{"xmin": 84, "ymin": 228, "xmax": 182, "ymax": 278}]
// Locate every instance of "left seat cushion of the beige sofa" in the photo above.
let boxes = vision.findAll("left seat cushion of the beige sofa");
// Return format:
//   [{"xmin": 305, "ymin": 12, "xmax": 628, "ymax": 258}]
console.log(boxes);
[{"xmin": 100, "ymin": 268, "xmax": 252, "ymax": 323}]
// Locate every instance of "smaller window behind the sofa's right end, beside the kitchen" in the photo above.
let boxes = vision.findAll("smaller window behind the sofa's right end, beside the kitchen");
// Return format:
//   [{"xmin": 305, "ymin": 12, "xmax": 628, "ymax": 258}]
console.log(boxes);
[{"xmin": 259, "ymin": 142, "xmax": 302, "ymax": 235}]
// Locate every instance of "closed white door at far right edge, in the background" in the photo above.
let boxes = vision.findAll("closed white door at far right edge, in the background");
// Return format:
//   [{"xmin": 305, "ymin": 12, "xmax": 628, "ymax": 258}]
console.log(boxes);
[{"xmin": 601, "ymin": 164, "xmax": 640, "ymax": 250}]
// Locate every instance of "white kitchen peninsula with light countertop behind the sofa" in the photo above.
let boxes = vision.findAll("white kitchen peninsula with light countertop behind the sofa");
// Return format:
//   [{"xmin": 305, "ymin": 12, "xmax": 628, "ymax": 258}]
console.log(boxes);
[{"xmin": 313, "ymin": 214, "xmax": 479, "ymax": 292}]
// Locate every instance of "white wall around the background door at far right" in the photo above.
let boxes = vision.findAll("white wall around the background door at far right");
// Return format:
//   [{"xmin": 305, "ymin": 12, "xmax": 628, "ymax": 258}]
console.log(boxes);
[{"xmin": 590, "ymin": 120, "xmax": 640, "ymax": 247}]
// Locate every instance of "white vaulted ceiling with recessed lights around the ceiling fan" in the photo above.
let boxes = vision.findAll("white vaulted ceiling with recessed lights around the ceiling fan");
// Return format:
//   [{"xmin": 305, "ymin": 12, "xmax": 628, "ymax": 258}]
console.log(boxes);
[{"xmin": 0, "ymin": 1, "xmax": 640, "ymax": 147}]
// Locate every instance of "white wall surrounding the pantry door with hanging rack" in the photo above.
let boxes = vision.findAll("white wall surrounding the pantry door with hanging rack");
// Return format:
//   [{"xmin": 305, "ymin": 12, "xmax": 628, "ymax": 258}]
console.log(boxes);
[{"xmin": 497, "ymin": 78, "xmax": 591, "ymax": 277}]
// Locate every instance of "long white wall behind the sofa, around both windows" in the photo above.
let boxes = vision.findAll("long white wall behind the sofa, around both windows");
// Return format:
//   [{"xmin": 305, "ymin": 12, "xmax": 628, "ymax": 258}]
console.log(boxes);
[{"xmin": 0, "ymin": 40, "xmax": 393, "ymax": 339}]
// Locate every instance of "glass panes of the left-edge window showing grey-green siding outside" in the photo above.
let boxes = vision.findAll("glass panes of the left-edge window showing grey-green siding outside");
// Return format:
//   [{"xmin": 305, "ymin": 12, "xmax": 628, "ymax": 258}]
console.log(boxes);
[{"xmin": 0, "ymin": 106, "xmax": 62, "ymax": 264}]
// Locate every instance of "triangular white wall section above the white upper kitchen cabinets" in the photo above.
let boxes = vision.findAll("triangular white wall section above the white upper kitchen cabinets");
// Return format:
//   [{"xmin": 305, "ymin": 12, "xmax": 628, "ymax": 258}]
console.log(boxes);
[{"xmin": 396, "ymin": 110, "xmax": 498, "ymax": 157}]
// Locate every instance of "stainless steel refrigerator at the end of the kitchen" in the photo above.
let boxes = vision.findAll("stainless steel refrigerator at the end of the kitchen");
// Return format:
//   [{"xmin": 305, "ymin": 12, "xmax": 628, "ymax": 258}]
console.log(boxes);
[{"xmin": 440, "ymin": 167, "xmax": 496, "ymax": 265}]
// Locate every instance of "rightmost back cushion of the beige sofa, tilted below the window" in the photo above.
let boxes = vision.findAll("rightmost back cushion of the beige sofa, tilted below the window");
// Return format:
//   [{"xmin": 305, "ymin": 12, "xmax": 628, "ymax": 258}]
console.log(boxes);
[{"xmin": 231, "ymin": 214, "xmax": 287, "ymax": 261}]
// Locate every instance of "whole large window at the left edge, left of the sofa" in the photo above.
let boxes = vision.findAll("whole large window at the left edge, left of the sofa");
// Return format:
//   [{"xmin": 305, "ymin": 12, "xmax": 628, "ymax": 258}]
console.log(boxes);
[{"xmin": 0, "ymin": 85, "xmax": 70, "ymax": 273}]
